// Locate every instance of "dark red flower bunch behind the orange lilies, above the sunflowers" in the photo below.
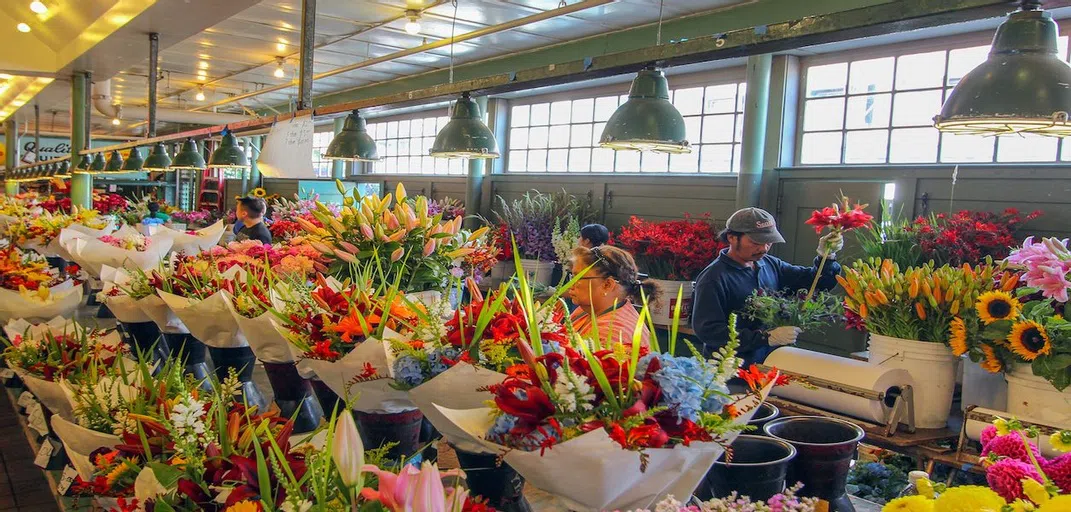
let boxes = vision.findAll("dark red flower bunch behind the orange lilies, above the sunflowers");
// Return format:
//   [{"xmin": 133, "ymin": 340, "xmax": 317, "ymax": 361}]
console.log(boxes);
[{"xmin": 905, "ymin": 208, "xmax": 1042, "ymax": 267}]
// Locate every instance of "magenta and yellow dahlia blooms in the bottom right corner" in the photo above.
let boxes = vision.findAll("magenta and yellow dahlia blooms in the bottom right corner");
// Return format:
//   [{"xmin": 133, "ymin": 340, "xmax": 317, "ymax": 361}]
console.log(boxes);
[{"xmin": 883, "ymin": 418, "xmax": 1071, "ymax": 512}]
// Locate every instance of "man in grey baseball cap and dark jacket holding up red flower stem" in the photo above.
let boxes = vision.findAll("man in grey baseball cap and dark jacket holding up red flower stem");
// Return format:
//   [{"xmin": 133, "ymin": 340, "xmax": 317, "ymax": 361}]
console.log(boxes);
[{"xmin": 692, "ymin": 208, "xmax": 844, "ymax": 366}]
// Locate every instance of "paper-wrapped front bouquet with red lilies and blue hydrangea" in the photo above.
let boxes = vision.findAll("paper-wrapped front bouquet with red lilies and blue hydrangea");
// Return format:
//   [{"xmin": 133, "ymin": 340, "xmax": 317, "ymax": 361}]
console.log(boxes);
[{"xmin": 430, "ymin": 308, "xmax": 779, "ymax": 510}]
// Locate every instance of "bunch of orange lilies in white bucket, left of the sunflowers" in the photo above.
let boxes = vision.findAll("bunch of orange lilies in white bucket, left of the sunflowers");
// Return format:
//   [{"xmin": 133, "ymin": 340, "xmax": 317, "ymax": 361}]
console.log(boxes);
[{"xmin": 836, "ymin": 259, "xmax": 1002, "ymax": 344}]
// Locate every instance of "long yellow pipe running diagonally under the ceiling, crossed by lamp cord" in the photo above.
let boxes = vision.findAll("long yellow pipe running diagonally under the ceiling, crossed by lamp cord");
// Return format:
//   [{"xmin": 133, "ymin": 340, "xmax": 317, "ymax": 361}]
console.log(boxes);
[{"xmin": 194, "ymin": 0, "xmax": 617, "ymax": 110}]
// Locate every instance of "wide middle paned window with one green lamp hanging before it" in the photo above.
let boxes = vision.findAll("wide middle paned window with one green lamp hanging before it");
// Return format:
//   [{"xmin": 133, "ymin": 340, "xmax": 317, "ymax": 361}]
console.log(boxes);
[{"xmin": 507, "ymin": 84, "xmax": 744, "ymax": 172}]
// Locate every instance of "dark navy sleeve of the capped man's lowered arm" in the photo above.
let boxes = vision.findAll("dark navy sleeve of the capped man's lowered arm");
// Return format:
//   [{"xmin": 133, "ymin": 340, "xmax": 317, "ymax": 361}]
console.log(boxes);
[{"xmin": 692, "ymin": 280, "xmax": 769, "ymax": 355}]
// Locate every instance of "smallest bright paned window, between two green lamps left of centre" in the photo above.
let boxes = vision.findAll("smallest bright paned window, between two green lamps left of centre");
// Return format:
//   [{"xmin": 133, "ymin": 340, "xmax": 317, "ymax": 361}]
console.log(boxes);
[{"xmin": 368, "ymin": 117, "xmax": 466, "ymax": 175}]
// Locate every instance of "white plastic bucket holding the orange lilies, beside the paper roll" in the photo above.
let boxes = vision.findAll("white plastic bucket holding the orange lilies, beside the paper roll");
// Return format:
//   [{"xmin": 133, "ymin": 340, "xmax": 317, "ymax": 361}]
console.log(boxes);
[{"xmin": 870, "ymin": 333, "xmax": 956, "ymax": 428}]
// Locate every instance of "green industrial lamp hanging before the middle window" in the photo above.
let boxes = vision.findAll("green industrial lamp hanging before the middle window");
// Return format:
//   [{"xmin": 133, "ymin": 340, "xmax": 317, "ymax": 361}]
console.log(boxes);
[{"xmin": 599, "ymin": 69, "xmax": 692, "ymax": 153}]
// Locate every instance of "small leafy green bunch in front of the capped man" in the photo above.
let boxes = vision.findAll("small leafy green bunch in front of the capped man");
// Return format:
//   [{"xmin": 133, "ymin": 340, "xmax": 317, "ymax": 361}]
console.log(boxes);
[{"xmin": 743, "ymin": 289, "xmax": 844, "ymax": 332}]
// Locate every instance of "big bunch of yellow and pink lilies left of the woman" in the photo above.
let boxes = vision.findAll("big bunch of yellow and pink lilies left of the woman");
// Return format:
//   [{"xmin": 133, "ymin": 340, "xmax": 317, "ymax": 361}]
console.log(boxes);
[{"xmin": 306, "ymin": 182, "xmax": 487, "ymax": 292}]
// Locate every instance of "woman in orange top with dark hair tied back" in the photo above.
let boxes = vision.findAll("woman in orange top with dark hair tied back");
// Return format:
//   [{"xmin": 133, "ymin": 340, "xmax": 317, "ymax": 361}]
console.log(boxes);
[{"xmin": 569, "ymin": 245, "xmax": 654, "ymax": 347}]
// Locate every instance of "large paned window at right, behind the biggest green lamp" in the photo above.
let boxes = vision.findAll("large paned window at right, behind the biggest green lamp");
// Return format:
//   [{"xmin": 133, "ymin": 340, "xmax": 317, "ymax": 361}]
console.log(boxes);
[{"xmin": 798, "ymin": 37, "xmax": 1071, "ymax": 165}]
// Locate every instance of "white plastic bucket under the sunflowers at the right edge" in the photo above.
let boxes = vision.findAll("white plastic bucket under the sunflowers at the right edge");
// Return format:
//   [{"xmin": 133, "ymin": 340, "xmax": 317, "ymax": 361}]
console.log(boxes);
[{"xmin": 1005, "ymin": 364, "xmax": 1071, "ymax": 428}]
